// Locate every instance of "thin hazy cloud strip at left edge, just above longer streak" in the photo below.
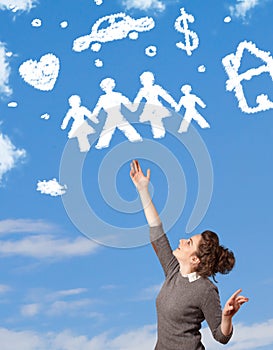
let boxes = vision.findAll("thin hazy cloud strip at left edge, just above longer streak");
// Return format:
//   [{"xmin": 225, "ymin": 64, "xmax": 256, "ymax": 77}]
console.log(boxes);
[{"xmin": 0, "ymin": 219, "xmax": 59, "ymax": 234}]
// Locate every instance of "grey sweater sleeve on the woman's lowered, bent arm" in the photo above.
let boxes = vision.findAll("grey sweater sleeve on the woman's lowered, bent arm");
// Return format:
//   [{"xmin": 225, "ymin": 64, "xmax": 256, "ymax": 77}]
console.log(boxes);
[{"xmin": 202, "ymin": 285, "xmax": 233, "ymax": 344}]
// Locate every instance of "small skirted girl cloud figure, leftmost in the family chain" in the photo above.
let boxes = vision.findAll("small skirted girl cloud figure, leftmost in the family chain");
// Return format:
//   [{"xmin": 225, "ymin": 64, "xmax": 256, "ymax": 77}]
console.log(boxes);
[{"xmin": 61, "ymin": 95, "xmax": 99, "ymax": 152}]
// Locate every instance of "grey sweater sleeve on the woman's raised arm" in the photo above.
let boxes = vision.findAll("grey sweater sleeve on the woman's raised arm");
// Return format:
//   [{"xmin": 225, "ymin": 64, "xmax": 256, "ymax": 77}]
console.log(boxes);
[{"xmin": 150, "ymin": 224, "xmax": 179, "ymax": 277}]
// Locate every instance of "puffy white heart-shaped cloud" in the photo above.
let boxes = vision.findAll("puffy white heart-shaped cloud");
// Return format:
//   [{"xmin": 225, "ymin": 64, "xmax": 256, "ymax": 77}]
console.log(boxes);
[{"xmin": 19, "ymin": 53, "xmax": 60, "ymax": 91}]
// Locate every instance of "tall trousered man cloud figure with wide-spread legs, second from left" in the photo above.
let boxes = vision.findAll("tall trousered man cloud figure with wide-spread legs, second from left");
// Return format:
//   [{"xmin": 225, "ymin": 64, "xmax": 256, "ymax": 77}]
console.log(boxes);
[{"xmin": 92, "ymin": 78, "xmax": 142, "ymax": 149}]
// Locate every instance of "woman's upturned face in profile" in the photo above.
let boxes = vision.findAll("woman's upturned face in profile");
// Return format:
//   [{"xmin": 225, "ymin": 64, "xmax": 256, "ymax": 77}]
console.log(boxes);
[{"xmin": 173, "ymin": 234, "xmax": 202, "ymax": 264}]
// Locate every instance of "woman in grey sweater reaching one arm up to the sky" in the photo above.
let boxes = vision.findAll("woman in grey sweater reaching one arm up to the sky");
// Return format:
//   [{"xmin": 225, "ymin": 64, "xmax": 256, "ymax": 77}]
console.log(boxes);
[{"xmin": 130, "ymin": 160, "xmax": 248, "ymax": 350}]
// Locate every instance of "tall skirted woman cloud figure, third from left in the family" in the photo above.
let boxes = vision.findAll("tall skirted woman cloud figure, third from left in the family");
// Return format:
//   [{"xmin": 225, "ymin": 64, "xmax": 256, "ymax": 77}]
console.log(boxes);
[{"xmin": 134, "ymin": 72, "xmax": 176, "ymax": 138}]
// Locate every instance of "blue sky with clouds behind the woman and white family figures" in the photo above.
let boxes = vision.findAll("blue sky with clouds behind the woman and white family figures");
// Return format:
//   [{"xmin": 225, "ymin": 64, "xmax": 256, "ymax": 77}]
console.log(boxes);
[{"xmin": 0, "ymin": 0, "xmax": 273, "ymax": 350}]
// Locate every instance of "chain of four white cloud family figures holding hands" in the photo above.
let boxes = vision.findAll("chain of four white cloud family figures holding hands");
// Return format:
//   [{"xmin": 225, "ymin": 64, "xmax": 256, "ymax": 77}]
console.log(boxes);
[{"xmin": 61, "ymin": 72, "xmax": 210, "ymax": 152}]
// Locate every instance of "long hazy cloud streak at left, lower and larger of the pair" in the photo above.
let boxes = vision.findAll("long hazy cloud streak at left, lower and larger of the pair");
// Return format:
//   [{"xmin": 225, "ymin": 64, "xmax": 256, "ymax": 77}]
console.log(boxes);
[{"xmin": 0, "ymin": 235, "xmax": 99, "ymax": 260}]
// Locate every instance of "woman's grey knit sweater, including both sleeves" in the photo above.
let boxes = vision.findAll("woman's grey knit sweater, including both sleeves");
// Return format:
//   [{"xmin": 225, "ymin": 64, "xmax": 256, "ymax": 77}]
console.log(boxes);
[{"xmin": 150, "ymin": 225, "xmax": 232, "ymax": 350}]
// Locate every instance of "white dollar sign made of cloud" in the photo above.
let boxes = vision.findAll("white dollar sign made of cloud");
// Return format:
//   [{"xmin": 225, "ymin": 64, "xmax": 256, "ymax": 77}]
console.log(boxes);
[{"xmin": 174, "ymin": 8, "xmax": 199, "ymax": 56}]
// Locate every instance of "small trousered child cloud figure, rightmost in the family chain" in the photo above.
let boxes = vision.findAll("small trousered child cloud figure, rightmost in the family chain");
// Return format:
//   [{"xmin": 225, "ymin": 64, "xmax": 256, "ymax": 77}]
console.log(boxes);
[{"xmin": 175, "ymin": 85, "xmax": 210, "ymax": 133}]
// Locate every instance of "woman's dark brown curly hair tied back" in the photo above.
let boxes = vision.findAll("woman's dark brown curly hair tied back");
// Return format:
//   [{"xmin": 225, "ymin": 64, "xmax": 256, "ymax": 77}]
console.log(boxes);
[{"xmin": 196, "ymin": 230, "xmax": 235, "ymax": 282}]
